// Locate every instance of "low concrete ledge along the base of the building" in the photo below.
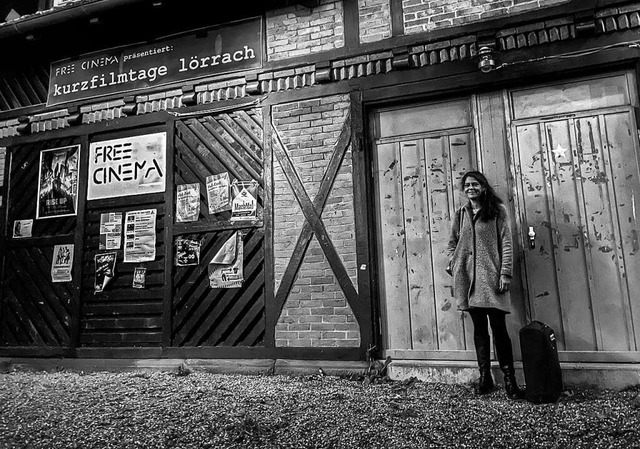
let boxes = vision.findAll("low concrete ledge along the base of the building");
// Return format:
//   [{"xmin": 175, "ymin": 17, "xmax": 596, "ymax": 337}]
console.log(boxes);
[{"xmin": 5, "ymin": 357, "xmax": 640, "ymax": 390}]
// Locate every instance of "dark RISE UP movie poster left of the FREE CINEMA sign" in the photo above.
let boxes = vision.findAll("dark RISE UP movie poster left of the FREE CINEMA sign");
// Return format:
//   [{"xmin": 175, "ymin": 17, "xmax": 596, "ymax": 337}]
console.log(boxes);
[{"xmin": 36, "ymin": 145, "xmax": 80, "ymax": 219}]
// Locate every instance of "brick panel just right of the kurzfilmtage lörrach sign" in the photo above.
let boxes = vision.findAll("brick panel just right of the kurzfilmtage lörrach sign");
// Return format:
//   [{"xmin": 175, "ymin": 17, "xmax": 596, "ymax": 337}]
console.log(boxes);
[{"xmin": 267, "ymin": 0, "xmax": 344, "ymax": 61}]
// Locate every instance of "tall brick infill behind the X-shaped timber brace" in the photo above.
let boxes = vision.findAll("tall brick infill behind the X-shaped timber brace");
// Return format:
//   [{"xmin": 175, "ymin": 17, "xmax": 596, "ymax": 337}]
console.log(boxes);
[{"xmin": 273, "ymin": 95, "xmax": 360, "ymax": 347}]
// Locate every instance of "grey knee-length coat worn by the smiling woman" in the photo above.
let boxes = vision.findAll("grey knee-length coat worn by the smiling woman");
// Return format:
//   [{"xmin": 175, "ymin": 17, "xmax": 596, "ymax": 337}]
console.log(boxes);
[{"xmin": 447, "ymin": 203, "xmax": 513, "ymax": 313}]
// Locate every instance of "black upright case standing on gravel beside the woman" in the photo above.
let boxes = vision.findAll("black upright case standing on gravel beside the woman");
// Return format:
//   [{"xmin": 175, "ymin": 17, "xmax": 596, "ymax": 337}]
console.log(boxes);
[{"xmin": 520, "ymin": 321, "xmax": 562, "ymax": 404}]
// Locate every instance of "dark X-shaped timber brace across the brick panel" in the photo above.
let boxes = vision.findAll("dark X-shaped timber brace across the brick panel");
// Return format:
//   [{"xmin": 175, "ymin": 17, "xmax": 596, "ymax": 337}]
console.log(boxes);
[{"xmin": 271, "ymin": 110, "xmax": 365, "ymax": 323}]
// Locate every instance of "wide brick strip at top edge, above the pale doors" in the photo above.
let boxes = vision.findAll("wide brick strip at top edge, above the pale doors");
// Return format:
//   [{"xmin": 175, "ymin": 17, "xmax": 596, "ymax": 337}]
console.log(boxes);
[{"xmin": 402, "ymin": 0, "xmax": 570, "ymax": 34}]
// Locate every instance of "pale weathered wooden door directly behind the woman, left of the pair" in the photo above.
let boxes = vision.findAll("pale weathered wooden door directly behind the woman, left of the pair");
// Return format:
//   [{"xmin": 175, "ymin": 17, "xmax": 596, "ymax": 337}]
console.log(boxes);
[{"xmin": 374, "ymin": 99, "xmax": 476, "ymax": 358}]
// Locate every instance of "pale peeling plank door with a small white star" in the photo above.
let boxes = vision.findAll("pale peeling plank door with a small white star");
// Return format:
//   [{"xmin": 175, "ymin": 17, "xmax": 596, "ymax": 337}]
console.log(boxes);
[{"xmin": 513, "ymin": 107, "xmax": 640, "ymax": 351}]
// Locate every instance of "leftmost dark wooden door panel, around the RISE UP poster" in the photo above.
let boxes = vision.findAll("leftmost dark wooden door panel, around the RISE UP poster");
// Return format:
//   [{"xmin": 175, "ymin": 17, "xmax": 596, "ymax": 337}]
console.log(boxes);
[{"xmin": 0, "ymin": 139, "xmax": 80, "ymax": 355}]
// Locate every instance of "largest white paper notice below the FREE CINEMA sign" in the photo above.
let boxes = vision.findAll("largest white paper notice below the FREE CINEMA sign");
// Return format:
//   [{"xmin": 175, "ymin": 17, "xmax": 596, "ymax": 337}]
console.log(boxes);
[{"xmin": 124, "ymin": 209, "xmax": 156, "ymax": 263}]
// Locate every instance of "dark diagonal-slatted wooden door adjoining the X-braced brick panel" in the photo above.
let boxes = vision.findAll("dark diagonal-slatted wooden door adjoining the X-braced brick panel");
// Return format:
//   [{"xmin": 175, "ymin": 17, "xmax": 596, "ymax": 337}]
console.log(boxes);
[{"xmin": 171, "ymin": 109, "xmax": 265, "ymax": 347}]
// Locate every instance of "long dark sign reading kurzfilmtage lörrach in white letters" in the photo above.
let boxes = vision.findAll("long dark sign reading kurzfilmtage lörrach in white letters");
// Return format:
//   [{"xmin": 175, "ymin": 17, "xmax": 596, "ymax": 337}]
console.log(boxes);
[{"xmin": 47, "ymin": 18, "xmax": 262, "ymax": 106}]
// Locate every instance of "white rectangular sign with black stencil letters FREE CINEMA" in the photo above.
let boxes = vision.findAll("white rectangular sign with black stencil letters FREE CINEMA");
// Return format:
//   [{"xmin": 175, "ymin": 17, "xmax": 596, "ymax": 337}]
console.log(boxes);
[{"xmin": 87, "ymin": 132, "xmax": 167, "ymax": 200}]
